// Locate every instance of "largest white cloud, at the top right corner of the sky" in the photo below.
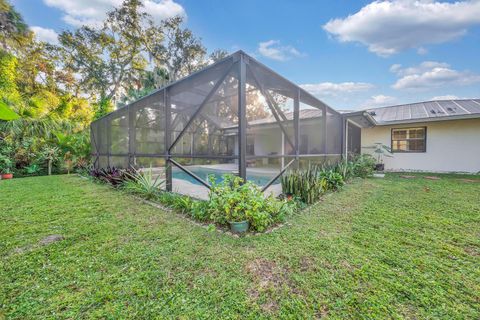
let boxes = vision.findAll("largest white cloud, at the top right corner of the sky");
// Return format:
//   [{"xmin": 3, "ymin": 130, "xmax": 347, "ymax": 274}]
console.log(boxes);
[{"xmin": 323, "ymin": 0, "xmax": 480, "ymax": 56}]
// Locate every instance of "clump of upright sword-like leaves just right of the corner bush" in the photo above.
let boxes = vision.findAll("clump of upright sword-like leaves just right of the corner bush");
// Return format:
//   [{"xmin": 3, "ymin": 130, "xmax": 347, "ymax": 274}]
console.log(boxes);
[{"xmin": 281, "ymin": 165, "xmax": 327, "ymax": 204}]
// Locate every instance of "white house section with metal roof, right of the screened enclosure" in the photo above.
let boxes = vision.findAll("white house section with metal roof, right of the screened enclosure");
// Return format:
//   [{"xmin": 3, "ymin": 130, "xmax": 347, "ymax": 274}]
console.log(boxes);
[{"xmin": 344, "ymin": 99, "xmax": 480, "ymax": 173}]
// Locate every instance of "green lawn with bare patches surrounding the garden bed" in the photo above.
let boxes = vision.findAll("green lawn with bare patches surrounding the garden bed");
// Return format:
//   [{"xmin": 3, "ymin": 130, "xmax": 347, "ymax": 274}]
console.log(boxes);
[{"xmin": 0, "ymin": 174, "xmax": 480, "ymax": 319}]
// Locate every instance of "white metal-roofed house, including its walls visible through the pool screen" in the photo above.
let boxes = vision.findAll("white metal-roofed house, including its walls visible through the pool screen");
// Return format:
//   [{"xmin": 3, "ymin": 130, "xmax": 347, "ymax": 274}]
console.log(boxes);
[{"xmin": 227, "ymin": 99, "xmax": 480, "ymax": 173}]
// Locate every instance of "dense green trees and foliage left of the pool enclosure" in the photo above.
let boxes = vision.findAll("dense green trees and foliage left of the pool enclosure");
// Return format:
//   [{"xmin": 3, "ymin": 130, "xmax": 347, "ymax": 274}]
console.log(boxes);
[{"xmin": 0, "ymin": 0, "xmax": 226, "ymax": 176}]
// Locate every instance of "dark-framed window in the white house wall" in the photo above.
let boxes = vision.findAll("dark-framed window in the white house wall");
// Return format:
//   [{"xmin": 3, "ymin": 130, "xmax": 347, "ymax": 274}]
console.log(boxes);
[{"xmin": 392, "ymin": 127, "xmax": 427, "ymax": 152}]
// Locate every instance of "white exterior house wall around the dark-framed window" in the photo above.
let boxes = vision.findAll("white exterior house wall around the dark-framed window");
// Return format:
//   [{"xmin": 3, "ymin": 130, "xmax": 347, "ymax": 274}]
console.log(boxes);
[{"xmin": 362, "ymin": 119, "xmax": 480, "ymax": 173}]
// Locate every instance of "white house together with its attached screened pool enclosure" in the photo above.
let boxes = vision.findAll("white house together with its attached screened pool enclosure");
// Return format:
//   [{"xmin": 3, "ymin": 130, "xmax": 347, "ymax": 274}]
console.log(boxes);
[{"xmin": 90, "ymin": 51, "xmax": 480, "ymax": 198}]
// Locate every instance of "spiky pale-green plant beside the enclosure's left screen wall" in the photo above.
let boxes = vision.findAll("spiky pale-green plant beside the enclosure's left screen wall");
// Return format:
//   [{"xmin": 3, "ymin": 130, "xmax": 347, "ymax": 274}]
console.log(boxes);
[{"xmin": 120, "ymin": 169, "xmax": 165, "ymax": 200}]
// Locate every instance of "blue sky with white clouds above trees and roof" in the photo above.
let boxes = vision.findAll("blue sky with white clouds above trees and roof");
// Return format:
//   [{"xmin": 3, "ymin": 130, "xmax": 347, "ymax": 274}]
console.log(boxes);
[{"xmin": 13, "ymin": 0, "xmax": 480, "ymax": 109}]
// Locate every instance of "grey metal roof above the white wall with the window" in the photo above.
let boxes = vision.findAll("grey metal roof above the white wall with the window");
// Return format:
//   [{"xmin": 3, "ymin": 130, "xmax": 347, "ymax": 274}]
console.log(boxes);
[{"xmin": 365, "ymin": 99, "xmax": 480, "ymax": 125}]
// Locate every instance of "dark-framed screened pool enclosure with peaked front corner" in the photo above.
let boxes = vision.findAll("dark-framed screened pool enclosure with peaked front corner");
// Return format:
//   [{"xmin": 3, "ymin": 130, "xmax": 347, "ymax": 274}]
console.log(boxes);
[{"xmin": 91, "ymin": 51, "xmax": 344, "ymax": 197}]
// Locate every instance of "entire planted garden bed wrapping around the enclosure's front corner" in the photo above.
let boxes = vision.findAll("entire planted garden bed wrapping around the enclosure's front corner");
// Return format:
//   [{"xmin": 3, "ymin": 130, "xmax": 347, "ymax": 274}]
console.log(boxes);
[{"xmin": 87, "ymin": 156, "xmax": 374, "ymax": 234}]
